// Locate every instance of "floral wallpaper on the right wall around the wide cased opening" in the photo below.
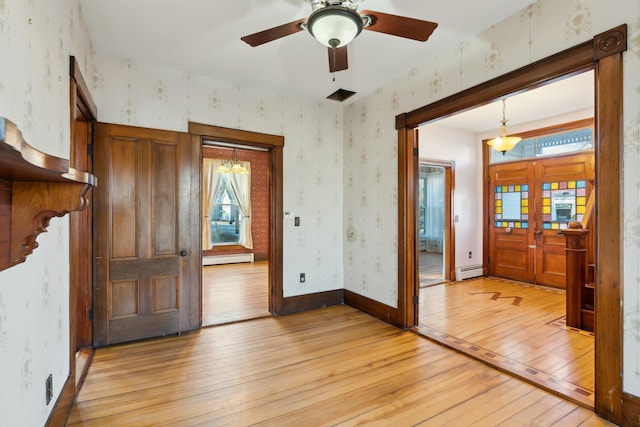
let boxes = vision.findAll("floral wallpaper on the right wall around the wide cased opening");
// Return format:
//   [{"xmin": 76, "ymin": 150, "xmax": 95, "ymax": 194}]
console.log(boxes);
[{"xmin": 343, "ymin": 0, "xmax": 640, "ymax": 395}]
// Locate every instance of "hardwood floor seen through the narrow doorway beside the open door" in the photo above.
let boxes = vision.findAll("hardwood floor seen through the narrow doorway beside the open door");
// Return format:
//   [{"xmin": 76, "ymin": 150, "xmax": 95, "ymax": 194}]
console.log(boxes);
[{"xmin": 202, "ymin": 261, "xmax": 269, "ymax": 326}]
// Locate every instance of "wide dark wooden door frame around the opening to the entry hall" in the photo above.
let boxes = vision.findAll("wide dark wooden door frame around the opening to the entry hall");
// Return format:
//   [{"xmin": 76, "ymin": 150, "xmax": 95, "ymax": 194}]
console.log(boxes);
[{"xmin": 396, "ymin": 24, "xmax": 624, "ymax": 424}]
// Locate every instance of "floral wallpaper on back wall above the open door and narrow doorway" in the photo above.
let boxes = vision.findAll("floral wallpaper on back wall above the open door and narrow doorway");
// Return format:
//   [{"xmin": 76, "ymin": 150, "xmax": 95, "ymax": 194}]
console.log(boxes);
[{"xmin": 89, "ymin": 53, "xmax": 343, "ymax": 297}]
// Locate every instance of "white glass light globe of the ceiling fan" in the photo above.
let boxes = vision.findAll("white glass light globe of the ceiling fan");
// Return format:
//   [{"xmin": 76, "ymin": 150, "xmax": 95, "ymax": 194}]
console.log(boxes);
[{"xmin": 307, "ymin": 6, "xmax": 362, "ymax": 48}]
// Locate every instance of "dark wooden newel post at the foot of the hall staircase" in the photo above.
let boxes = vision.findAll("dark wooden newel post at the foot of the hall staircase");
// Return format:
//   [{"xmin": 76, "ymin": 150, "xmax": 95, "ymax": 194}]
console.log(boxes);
[{"xmin": 562, "ymin": 222, "xmax": 589, "ymax": 328}]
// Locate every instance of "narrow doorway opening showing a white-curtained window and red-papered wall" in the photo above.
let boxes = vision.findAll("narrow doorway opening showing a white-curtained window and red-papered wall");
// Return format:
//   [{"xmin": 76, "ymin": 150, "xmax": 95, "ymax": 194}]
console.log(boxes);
[{"xmin": 202, "ymin": 145, "xmax": 271, "ymax": 326}]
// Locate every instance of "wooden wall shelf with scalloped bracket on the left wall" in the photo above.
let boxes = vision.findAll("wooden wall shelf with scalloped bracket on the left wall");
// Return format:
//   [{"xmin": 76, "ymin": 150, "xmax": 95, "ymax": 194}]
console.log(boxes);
[{"xmin": 0, "ymin": 117, "xmax": 96, "ymax": 271}]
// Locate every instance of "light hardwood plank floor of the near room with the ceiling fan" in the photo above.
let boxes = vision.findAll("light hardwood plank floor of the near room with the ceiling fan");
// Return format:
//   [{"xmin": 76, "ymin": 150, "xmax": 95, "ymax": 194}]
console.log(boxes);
[{"xmin": 67, "ymin": 305, "xmax": 607, "ymax": 427}]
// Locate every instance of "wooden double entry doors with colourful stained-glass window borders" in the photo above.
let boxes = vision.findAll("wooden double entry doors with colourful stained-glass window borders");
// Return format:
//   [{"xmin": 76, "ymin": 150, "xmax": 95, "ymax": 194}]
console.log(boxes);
[{"xmin": 486, "ymin": 152, "xmax": 594, "ymax": 289}]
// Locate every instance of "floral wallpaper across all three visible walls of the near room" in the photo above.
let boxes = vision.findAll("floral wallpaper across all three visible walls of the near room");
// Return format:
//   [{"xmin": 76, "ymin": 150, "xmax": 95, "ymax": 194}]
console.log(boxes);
[{"xmin": 0, "ymin": 0, "xmax": 640, "ymax": 425}]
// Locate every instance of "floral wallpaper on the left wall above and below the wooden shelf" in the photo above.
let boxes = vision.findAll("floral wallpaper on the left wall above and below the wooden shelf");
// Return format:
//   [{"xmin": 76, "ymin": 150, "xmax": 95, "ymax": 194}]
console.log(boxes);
[{"xmin": 0, "ymin": 0, "xmax": 92, "ymax": 426}]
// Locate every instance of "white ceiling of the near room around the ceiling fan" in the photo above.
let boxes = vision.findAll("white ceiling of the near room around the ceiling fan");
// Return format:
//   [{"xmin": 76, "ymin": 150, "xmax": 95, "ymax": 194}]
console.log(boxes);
[{"xmin": 80, "ymin": 0, "xmax": 533, "ymax": 104}]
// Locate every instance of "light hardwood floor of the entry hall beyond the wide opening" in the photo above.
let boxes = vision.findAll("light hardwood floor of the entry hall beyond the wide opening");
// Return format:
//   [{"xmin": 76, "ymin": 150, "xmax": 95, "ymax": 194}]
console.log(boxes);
[{"xmin": 419, "ymin": 278, "xmax": 594, "ymax": 407}]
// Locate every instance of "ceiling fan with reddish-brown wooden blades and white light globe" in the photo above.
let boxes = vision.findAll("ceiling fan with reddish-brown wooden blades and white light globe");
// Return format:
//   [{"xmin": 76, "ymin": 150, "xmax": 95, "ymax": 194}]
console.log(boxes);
[{"xmin": 240, "ymin": 0, "xmax": 438, "ymax": 72}]
